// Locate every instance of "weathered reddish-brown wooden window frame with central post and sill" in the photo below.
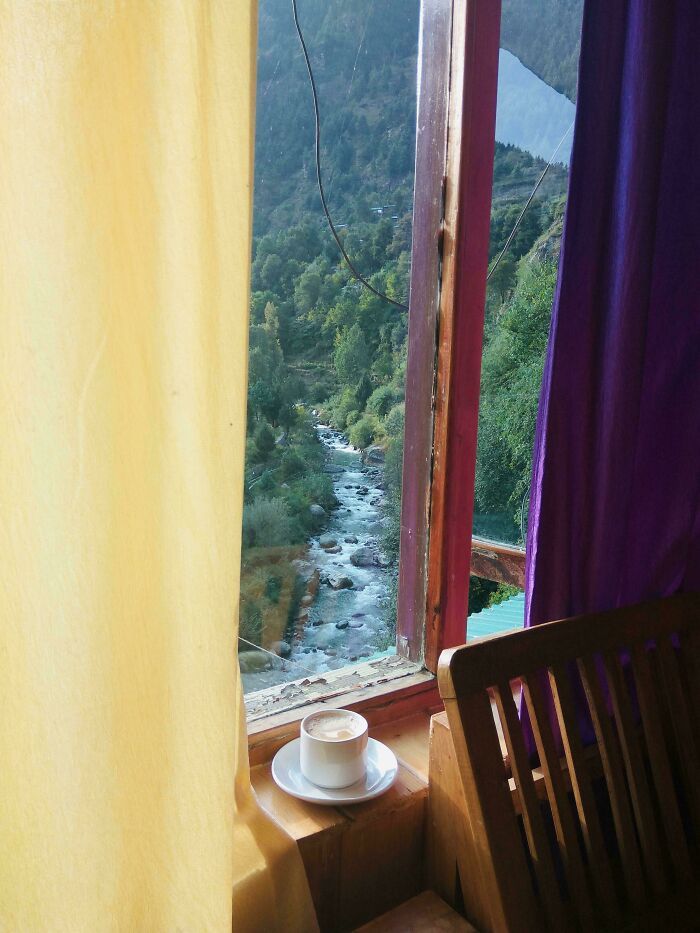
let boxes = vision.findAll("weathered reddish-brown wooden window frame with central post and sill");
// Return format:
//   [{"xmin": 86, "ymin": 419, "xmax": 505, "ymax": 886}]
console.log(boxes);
[{"xmin": 249, "ymin": 0, "xmax": 524, "ymax": 748}]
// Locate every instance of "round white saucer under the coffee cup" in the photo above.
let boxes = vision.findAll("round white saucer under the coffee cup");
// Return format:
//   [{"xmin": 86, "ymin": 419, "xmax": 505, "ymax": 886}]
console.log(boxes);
[{"xmin": 272, "ymin": 739, "xmax": 399, "ymax": 807}]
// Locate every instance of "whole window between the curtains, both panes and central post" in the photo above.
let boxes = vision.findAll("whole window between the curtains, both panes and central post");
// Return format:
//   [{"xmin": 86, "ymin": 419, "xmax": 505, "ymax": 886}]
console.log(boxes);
[{"xmin": 240, "ymin": 0, "xmax": 581, "ymax": 728}]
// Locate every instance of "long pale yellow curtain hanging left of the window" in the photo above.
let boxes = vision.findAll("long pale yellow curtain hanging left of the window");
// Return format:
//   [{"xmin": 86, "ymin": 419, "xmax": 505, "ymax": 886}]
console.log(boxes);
[{"xmin": 0, "ymin": 0, "xmax": 315, "ymax": 933}]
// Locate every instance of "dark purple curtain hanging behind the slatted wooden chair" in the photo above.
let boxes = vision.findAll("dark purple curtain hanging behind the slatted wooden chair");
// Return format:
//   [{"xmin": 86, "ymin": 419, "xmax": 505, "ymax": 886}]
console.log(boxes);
[{"xmin": 526, "ymin": 0, "xmax": 700, "ymax": 625}]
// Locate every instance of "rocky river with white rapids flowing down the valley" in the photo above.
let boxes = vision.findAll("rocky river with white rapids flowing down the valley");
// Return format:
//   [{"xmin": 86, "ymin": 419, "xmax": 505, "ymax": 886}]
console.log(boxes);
[{"xmin": 242, "ymin": 424, "xmax": 394, "ymax": 692}]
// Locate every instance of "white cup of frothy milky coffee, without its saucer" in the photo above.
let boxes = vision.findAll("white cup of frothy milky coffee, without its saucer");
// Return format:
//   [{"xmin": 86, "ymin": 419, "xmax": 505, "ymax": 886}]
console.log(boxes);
[{"xmin": 299, "ymin": 709, "xmax": 367, "ymax": 789}]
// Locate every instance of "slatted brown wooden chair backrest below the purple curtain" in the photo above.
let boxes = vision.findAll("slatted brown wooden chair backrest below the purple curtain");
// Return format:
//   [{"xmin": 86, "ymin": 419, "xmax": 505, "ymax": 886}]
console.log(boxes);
[{"xmin": 439, "ymin": 594, "xmax": 700, "ymax": 933}]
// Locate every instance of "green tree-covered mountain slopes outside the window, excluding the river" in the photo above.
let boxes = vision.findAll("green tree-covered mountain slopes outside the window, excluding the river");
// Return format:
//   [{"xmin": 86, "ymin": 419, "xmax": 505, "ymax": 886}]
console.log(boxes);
[{"xmin": 241, "ymin": 0, "xmax": 580, "ymax": 656}]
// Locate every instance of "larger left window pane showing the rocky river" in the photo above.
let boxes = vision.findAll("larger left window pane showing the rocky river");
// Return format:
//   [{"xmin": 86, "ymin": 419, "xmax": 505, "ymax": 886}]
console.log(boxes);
[{"xmin": 239, "ymin": 0, "xmax": 426, "ymax": 693}]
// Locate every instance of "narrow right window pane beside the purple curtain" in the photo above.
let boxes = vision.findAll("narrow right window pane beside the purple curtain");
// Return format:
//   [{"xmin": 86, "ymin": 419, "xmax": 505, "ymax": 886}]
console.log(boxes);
[{"xmin": 468, "ymin": 0, "xmax": 582, "ymax": 630}]
